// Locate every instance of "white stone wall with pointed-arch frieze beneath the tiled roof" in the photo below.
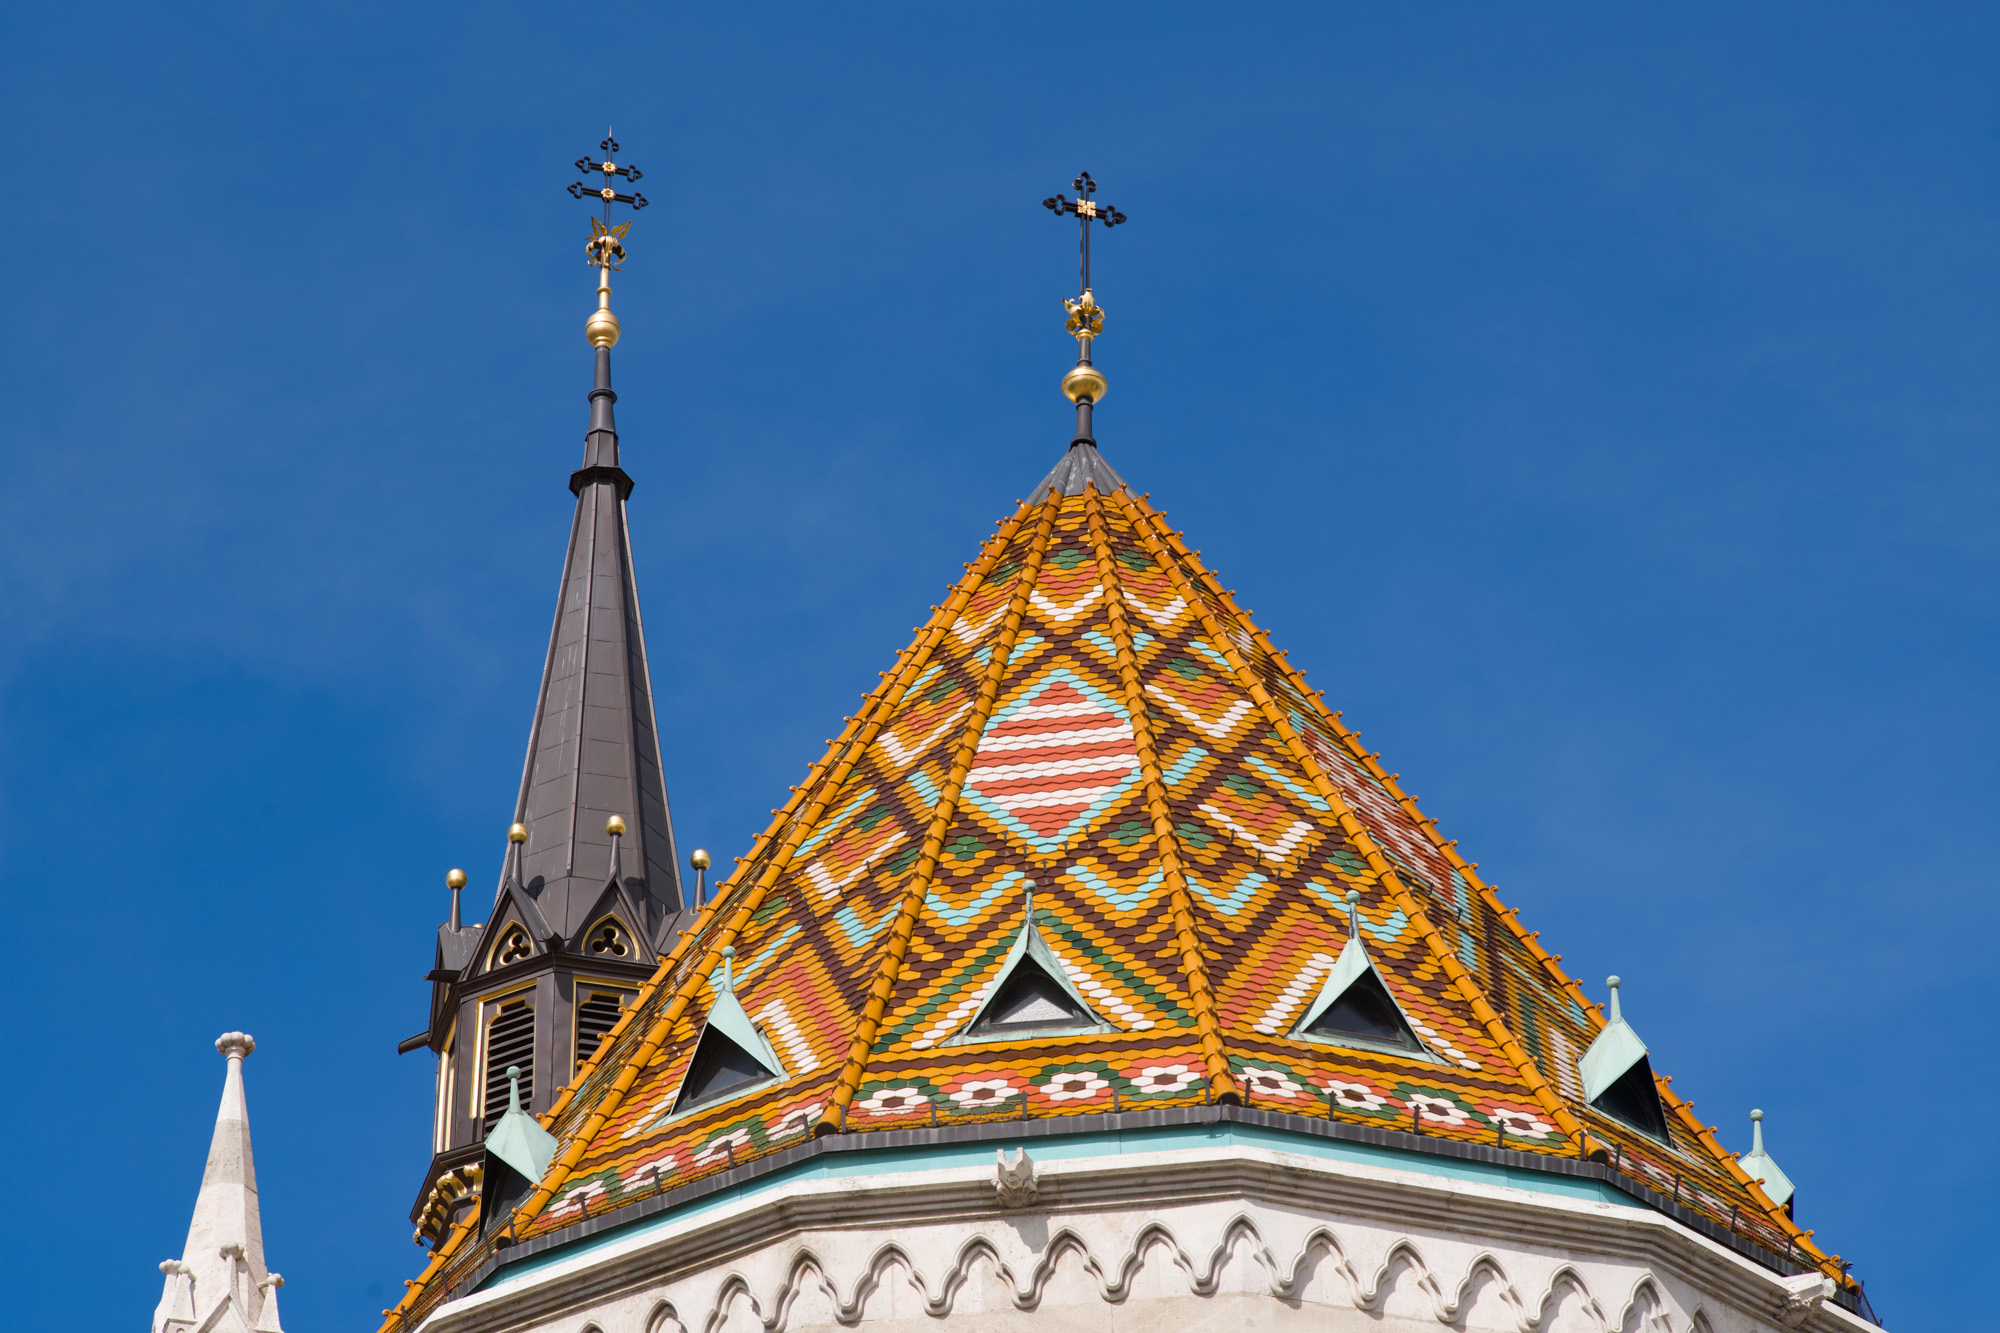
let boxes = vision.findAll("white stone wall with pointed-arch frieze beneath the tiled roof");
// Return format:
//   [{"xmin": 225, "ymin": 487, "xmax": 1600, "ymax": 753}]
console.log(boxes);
[{"xmin": 426, "ymin": 1147, "xmax": 1870, "ymax": 1333}]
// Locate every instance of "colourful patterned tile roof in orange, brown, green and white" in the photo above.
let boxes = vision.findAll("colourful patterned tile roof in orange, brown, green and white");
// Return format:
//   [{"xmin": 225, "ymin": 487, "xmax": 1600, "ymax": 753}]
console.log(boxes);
[{"xmin": 386, "ymin": 444, "xmax": 1840, "ymax": 1327}]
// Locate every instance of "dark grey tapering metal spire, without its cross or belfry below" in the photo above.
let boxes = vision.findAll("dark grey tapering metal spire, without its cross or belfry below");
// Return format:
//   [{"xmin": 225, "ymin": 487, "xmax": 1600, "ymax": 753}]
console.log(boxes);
[{"xmin": 514, "ymin": 326, "xmax": 680, "ymax": 939}]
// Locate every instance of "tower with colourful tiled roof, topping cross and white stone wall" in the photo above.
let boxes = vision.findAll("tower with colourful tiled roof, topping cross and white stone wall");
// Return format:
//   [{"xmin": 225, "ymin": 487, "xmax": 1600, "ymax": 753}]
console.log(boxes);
[{"xmin": 382, "ymin": 164, "xmax": 1878, "ymax": 1333}]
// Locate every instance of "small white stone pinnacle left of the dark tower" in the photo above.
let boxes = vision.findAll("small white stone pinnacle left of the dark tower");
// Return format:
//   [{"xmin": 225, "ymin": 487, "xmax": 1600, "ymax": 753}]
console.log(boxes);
[{"xmin": 152, "ymin": 1033, "xmax": 284, "ymax": 1333}]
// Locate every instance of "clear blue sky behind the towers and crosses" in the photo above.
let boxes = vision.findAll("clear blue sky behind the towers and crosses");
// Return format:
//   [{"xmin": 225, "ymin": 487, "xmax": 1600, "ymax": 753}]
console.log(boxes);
[{"xmin": 0, "ymin": 2, "xmax": 2000, "ymax": 1333}]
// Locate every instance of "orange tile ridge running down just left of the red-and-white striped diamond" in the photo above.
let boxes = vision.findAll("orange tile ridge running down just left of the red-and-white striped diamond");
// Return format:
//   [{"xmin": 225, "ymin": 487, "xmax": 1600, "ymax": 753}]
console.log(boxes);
[{"xmin": 812, "ymin": 494, "xmax": 1060, "ymax": 1135}]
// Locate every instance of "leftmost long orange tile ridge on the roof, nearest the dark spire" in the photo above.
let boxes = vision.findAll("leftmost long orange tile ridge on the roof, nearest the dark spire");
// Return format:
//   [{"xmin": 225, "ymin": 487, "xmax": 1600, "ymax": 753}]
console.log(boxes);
[{"xmin": 496, "ymin": 506, "xmax": 1026, "ymax": 1248}]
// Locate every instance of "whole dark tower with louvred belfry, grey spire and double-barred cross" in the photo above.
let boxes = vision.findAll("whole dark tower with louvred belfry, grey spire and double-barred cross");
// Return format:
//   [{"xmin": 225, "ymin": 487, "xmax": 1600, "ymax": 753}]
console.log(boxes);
[{"xmin": 398, "ymin": 138, "xmax": 690, "ymax": 1243}]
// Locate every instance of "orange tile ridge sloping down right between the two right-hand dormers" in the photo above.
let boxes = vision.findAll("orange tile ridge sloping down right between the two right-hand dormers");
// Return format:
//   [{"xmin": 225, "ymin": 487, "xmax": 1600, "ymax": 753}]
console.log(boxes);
[{"xmin": 1132, "ymin": 492, "xmax": 1588, "ymax": 1143}]
